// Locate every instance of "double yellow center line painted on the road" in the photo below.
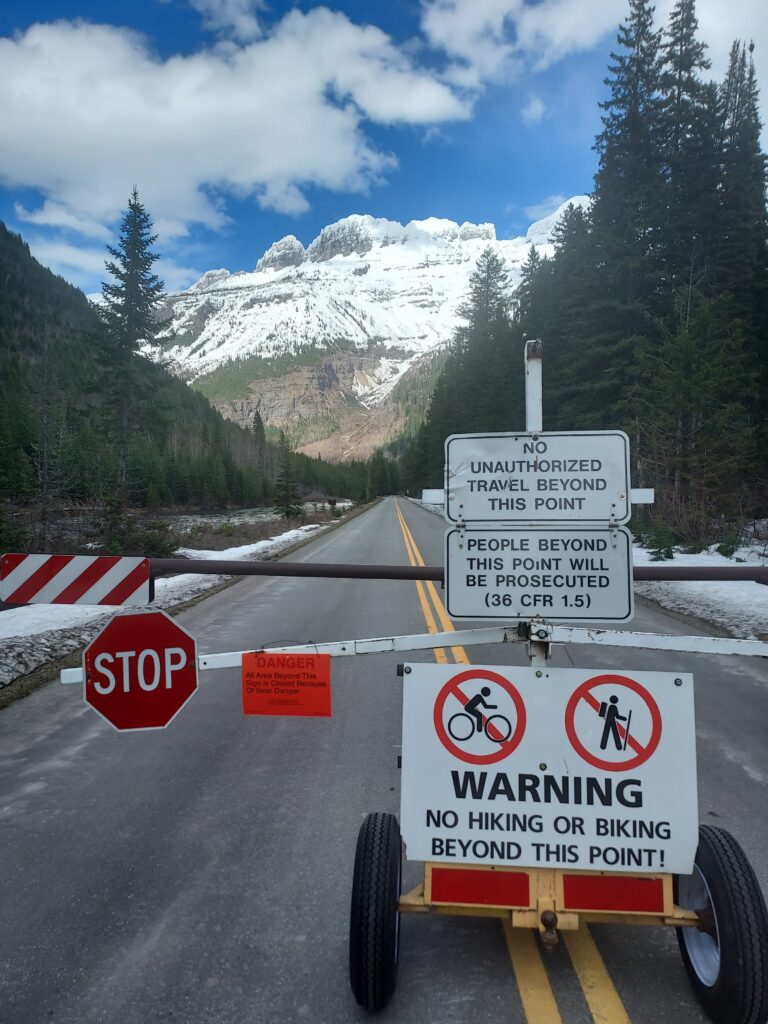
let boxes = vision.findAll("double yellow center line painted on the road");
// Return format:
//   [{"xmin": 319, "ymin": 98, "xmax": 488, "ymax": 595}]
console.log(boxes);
[{"xmin": 395, "ymin": 502, "xmax": 631, "ymax": 1024}]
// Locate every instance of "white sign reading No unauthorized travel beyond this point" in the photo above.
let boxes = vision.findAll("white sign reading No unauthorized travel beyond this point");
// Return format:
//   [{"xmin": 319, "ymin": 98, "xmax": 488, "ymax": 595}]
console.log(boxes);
[{"xmin": 445, "ymin": 430, "xmax": 632, "ymax": 523}]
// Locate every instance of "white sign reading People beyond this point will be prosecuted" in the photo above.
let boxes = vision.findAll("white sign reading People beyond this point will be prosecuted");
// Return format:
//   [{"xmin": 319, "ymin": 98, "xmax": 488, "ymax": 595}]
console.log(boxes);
[{"xmin": 445, "ymin": 525, "xmax": 635, "ymax": 623}]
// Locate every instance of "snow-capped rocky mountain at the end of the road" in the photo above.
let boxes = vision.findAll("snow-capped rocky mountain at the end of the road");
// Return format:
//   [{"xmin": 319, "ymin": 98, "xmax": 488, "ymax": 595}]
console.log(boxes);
[{"xmin": 147, "ymin": 196, "xmax": 589, "ymax": 456}]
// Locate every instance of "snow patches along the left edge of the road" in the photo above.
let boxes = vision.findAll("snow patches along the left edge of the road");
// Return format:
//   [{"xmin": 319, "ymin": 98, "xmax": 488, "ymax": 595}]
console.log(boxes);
[{"xmin": 0, "ymin": 523, "xmax": 328, "ymax": 686}]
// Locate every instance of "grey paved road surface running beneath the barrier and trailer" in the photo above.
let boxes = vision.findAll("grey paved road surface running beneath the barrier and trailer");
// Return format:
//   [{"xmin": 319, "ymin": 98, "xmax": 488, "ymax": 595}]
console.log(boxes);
[{"xmin": 0, "ymin": 491, "xmax": 768, "ymax": 1024}]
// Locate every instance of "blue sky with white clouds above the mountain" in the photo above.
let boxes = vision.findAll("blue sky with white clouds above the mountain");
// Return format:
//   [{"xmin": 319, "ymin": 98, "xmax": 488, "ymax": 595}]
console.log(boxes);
[{"xmin": 0, "ymin": 0, "xmax": 768, "ymax": 292}]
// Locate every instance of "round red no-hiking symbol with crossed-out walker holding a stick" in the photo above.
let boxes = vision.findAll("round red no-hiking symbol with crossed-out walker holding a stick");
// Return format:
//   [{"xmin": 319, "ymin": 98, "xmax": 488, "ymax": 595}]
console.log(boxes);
[{"xmin": 565, "ymin": 673, "xmax": 662, "ymax": 772}]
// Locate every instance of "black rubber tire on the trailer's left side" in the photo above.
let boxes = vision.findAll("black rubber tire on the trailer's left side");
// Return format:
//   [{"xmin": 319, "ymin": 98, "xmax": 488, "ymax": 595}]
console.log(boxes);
[{"xmin": 349, "ymin": 812, "xmax": 401, "ymax": 1012}]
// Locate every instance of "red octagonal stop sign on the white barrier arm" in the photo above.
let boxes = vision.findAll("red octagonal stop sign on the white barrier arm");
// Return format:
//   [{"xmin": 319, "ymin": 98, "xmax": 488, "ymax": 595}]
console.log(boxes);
[{"xmin": 83, "ymin": 611, "xmax": 198, "ymax": 729}]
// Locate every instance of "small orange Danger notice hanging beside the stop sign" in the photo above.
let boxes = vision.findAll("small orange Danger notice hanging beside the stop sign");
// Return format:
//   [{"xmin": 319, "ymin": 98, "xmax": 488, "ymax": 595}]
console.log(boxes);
[{"xmin": 243, "ymin": 651, "xmax": 331, "ymax": 718}]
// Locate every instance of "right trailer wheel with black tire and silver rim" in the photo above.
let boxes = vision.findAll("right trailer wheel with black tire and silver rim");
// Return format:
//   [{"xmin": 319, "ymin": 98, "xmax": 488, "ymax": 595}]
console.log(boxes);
[{"xmin": 675, "ymin": 825, "xmax": 768, "ymax": 1024}]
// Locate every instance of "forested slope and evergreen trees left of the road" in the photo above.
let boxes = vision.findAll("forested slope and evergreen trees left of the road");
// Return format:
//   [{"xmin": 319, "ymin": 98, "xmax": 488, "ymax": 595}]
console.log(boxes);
[{"xmin": 0, "ymin": 196, "xmax": 368, "ymax": 550}]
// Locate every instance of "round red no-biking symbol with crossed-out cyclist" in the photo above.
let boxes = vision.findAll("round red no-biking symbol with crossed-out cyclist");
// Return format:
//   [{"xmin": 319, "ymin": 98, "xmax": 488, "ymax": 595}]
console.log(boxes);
[{"xmin": 434, "ymin": 669, "xmax": 525, "ymax": 765}]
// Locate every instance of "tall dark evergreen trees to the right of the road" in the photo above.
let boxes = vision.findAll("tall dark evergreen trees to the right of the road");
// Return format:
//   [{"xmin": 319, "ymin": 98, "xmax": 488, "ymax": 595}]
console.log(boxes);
[{"xmin": 400, "ymin": 0, "xmax": 768, "ymax": 544}]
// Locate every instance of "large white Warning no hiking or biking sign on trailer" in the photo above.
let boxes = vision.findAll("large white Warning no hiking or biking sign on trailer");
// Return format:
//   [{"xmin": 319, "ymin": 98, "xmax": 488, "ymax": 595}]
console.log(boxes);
[{"xmin": 400, "ymin": 664, "xmax": 698, "ymax": 874}]
